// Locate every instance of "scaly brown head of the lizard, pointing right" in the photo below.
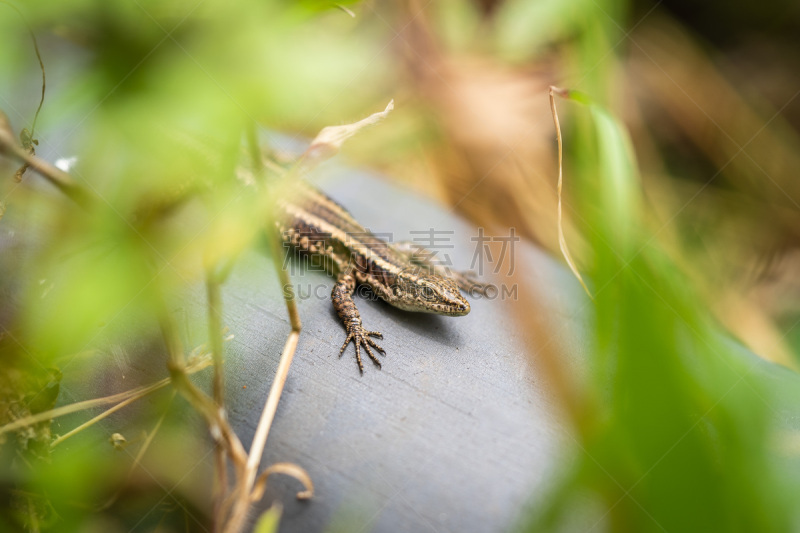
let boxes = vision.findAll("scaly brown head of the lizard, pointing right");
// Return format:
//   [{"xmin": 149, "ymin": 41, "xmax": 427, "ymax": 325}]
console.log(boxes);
[{"xmin": 391, "ymin": 269, "xmax": 469, "ymax": 316}]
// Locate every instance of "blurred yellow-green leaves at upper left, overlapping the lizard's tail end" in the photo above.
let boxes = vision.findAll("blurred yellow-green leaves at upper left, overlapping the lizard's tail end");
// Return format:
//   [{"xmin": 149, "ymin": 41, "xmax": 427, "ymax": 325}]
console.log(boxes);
[{"xmin": 2, "ymin": 0, "xmax": 388, "ymax": 368}]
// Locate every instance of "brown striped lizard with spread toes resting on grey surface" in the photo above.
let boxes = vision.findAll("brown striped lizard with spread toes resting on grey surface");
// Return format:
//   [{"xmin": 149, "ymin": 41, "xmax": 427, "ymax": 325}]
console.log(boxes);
[{"xmin": 274, "ymin": 180, "xmax": 488, "ymax": 374}]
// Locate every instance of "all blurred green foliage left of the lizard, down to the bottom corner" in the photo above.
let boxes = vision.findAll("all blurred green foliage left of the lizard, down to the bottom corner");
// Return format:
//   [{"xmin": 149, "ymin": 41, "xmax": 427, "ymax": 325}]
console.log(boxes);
[{"xmin": 0, "ymin": 0, "xmax": 385, "ymax": 531}]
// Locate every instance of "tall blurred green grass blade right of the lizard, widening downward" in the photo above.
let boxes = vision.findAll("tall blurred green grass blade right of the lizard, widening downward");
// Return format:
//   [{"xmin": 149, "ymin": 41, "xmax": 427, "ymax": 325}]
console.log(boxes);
[{"xmin": 516, "ymin": 1, "xmax": 800, "ymax": 532}]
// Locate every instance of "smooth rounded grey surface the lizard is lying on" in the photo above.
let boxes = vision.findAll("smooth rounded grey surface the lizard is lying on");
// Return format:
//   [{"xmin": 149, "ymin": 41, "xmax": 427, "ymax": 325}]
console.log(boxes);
[{"xmin": 225, "ymin": 171, "xmax": 592, "ymax": 532}]
